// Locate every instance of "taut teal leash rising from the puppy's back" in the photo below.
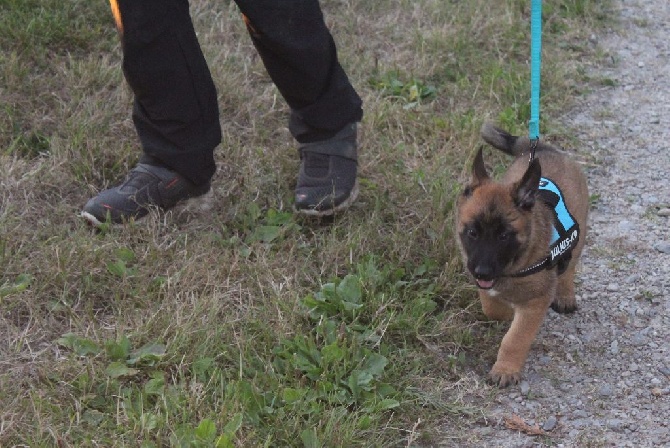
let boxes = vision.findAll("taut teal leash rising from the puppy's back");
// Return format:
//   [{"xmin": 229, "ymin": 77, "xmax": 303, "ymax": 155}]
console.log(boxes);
[{"xmin": 528, "ymin": 0, "xmax": 542, "ymax": 160}]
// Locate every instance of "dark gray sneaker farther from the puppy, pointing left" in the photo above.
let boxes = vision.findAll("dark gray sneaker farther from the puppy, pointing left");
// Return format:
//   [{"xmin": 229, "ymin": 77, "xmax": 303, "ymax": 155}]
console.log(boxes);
[{"xmin": 81, "ymin": 163, "xmax": 210, "ymax": 227}]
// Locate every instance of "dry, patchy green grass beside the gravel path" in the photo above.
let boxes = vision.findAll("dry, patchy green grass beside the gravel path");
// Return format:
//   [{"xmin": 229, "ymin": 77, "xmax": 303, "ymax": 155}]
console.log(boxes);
[{"xmin": 0, "ymin": 0, "xmax": 607, "ymax": 447}]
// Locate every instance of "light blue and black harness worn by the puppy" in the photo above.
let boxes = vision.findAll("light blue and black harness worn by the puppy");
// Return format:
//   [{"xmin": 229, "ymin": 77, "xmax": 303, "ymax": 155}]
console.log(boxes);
[{"xmin": 510, "ymin": 177, "xmax": 579, "ymax": 277}]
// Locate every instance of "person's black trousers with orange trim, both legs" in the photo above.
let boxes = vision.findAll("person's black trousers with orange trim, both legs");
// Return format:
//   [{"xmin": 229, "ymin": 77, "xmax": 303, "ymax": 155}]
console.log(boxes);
[{"xmin": 111, "ymin": 0, "xmax": 363, "ymax": 184}]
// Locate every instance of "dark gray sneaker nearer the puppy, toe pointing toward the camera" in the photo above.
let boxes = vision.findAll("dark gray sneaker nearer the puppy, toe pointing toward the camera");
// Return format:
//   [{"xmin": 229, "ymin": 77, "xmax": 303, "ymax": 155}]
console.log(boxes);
[{"xmin": 294, "ymin": 123, "xmax": 358, "ymax": 216}]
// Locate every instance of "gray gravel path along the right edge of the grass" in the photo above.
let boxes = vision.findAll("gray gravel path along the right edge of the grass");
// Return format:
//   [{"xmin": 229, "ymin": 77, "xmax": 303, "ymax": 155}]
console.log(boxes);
[{"xmin": 470, "ymin": 0, "xmax": 670, "ymax": 448}]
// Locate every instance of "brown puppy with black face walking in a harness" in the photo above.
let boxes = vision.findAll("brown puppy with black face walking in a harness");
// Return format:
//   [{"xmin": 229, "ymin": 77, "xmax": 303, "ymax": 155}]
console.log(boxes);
[{"xmin": 456, "ymin": 124, "xmax": 589, "ymax": 387}]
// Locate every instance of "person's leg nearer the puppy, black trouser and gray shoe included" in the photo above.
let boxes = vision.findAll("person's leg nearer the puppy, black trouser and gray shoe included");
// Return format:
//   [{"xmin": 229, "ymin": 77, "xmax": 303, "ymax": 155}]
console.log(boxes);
[{"xmin": 236, "ymin": 0, "xmax": 363, "ymax": 215}]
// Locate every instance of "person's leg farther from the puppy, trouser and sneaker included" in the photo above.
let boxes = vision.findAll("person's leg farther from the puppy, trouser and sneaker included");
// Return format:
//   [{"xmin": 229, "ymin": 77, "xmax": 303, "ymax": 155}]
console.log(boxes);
[{"xmin": 82, "ymin": 0, "xmax": 221, "ymax": 224}]
